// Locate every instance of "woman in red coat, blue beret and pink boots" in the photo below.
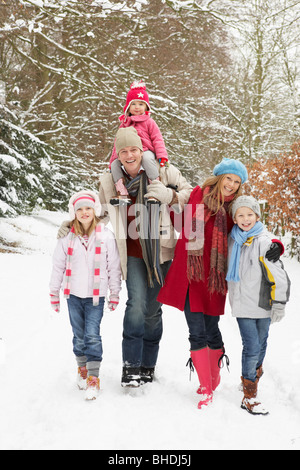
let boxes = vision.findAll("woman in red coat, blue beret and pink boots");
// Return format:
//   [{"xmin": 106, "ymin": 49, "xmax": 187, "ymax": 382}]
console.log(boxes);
[{"xmin": 158, "ymin": 158, "xmax": 248, "ymax": 408}]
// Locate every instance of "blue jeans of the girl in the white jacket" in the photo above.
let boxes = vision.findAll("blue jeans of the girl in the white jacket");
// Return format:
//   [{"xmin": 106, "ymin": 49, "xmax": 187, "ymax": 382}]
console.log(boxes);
[{"xmin": 67, "ymin": 295, "xmax": 105, "ymax": 362}]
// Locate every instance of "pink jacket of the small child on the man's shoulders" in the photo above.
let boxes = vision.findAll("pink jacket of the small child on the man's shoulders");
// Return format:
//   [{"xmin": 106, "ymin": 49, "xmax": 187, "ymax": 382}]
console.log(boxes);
[{"xmin": 109, "ymin": 114, "xmax": 168, "ymax": 166}]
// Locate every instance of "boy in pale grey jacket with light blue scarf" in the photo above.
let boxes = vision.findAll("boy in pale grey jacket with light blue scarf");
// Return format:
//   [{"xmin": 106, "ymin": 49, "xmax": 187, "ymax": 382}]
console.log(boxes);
[{"xmin": 226, "ymin": 196, "xmax": 290, "ymax": 414}]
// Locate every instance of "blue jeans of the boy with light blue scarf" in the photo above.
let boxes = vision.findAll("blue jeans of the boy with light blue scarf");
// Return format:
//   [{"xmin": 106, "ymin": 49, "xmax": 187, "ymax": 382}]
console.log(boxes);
[{"xmin": 237, "ymin": 318, "xmax": 271, "ymax": 382}]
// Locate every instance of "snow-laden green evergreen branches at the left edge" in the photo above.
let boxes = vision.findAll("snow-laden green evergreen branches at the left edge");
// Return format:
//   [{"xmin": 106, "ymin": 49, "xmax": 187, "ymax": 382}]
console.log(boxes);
[{"xmin": 0, "ymin": 105, "xmax": 93, "ymax": 216}]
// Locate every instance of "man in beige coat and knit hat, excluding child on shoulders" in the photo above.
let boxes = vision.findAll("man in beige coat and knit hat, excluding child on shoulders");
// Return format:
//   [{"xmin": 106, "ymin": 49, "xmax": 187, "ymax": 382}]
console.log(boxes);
[{"xmin": 99, "ymin": 127, "xmax": 192, "ymax": 387}]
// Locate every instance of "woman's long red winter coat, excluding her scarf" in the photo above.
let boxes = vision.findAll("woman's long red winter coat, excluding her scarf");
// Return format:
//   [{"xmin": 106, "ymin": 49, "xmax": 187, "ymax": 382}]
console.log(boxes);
[{"xmin": 157, "ymin": 186, "xmax": 233, "ymax": 316}]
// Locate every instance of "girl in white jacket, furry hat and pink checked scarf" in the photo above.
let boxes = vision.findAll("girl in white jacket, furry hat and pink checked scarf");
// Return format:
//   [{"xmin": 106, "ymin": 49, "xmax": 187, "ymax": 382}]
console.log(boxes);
[{"xmin": 50, "ymin": 190, "xmax": 121, "ymax": 400}]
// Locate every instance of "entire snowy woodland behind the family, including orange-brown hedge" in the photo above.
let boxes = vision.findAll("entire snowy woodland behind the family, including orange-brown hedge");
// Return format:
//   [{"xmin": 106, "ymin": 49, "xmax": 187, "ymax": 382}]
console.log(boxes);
[{"xmin": 0, "ymin": 0, "xmax": 300, "ymax": 259}]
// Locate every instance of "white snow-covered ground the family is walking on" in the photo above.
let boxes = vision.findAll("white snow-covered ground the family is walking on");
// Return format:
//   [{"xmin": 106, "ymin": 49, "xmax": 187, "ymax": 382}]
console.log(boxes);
[{"xmin": 0, "ymin": 211, "xmax": 300, "ymax": 450}]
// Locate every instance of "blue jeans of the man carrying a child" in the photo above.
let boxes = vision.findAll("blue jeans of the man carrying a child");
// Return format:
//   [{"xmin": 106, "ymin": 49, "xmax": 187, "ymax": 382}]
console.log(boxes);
[{"xmin": 122, "ymin": 256, "xmax": 171, "ymax": 368}]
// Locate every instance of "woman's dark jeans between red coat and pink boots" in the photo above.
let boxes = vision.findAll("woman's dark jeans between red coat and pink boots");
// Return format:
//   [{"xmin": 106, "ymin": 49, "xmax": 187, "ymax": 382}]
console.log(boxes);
[{"xmin": 184, "ymin": 292, "xmax": 223, "ymax": 351}]
